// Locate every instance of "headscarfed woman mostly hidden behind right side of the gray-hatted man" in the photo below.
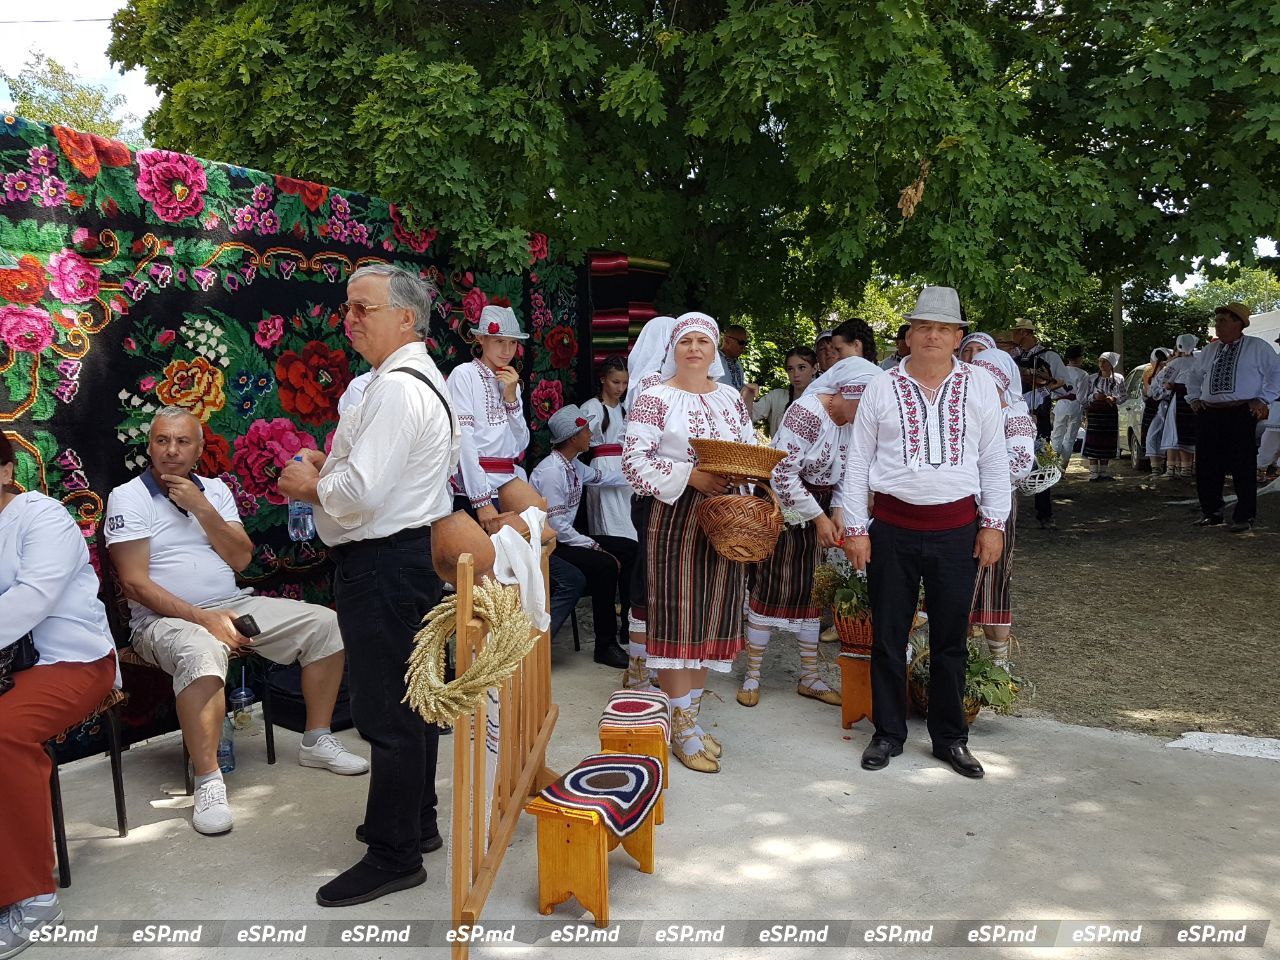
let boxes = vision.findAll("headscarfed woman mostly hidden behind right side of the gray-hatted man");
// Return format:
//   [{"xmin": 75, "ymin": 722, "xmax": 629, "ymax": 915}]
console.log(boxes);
[{"xmin": 960, "ymin": 333, "xmax": 1036, "ymax": 666}]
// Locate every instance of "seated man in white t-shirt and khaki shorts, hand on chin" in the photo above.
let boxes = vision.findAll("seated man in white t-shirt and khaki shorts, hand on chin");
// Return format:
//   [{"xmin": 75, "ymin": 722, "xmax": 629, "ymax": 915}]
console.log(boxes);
[{"xmin": 106, "ymin": 407, "xmax": 369, "ymax": 833}]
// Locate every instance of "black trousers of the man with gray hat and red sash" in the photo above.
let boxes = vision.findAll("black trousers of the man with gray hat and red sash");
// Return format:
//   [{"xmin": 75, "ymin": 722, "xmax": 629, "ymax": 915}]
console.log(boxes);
[{"xmin": 867, "ymin": 520, "xmax": 978, "ymax": 748}]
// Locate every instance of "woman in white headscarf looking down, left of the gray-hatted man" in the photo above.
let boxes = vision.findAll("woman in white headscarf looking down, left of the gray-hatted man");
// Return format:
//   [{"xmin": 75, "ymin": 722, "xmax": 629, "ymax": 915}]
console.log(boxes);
[{"xmin": 737, "ymin": 357, "xmax": 884, "ymax": 707}]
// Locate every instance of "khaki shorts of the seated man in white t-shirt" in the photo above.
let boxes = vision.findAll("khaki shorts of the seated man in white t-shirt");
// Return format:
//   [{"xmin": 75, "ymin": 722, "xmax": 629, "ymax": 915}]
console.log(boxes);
[{"xmin": 133, "ymin": 595, "xmax": 342, "ymax": 695}]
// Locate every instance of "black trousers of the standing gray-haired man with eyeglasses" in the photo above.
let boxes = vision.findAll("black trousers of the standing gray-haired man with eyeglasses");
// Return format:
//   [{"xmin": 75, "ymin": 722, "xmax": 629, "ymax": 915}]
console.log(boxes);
[{"xmin": 330, "ymin": 527, "xmax": 443, "ymax": 870}]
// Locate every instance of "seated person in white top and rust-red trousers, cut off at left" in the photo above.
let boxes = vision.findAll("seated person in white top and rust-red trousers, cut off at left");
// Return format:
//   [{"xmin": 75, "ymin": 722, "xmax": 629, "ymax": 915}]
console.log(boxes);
[{"xmin": 0, "ymin": 434, "xmax": 120, "ymax": 956}]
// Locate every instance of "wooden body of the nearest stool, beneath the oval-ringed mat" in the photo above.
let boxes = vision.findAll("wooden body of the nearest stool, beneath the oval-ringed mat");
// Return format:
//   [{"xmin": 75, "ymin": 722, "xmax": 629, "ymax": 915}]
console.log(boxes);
[{"xmin": 525, "ymin": 796, "xmax": 662, "ymax": 927}]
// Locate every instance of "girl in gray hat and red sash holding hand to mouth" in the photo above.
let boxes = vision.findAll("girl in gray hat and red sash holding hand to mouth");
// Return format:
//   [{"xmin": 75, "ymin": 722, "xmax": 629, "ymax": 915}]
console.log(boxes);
[{"xmin": 448, "ymin": 303, "xmax": 529, "ymax": 532}]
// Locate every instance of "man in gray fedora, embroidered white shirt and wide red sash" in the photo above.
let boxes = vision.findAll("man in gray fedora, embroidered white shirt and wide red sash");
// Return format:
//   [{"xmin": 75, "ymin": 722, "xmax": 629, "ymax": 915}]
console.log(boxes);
[{"xmin": 840, "ymin": 287, "xmax": 1010, "ymax": 778}]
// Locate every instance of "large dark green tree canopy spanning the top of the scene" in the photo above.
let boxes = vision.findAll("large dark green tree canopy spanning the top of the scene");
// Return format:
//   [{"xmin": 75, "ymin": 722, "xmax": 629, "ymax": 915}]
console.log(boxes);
[{"xmin": 110, "ymin": 0, "xmax": 1280, "ymax": 323}]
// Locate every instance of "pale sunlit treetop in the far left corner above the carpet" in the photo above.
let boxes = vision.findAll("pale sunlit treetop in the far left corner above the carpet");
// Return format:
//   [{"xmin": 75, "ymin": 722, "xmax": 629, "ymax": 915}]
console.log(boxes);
[{"xmin": 0, "ymin": 52, "xmax": 140, "ymax": 142}]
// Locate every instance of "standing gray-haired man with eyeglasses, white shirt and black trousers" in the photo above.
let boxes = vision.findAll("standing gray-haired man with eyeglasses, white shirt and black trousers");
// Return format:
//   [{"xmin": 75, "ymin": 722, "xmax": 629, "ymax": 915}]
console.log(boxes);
[{"xmin": 278, "ymin": 264, "xmax": 461, "ymax": 906}]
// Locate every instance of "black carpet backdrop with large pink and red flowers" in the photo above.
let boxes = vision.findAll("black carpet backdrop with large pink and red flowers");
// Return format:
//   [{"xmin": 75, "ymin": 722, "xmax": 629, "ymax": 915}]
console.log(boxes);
[{"xmin": 0, "ymin": 116, "xmax": 589, "ymax": 752}]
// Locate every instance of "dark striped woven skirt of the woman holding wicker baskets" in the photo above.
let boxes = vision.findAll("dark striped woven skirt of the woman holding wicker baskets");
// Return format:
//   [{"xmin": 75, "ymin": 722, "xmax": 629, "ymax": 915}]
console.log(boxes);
[{"xmin": 643, "ymin": 486, "xmax": 746, "ymax": 671}]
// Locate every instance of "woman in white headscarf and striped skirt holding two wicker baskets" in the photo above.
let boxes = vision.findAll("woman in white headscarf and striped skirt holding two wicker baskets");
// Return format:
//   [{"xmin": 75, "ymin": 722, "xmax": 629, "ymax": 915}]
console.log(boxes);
[{"xmin": 622, "ymin": 312, "xmax": 753, "ymax": 773}]
